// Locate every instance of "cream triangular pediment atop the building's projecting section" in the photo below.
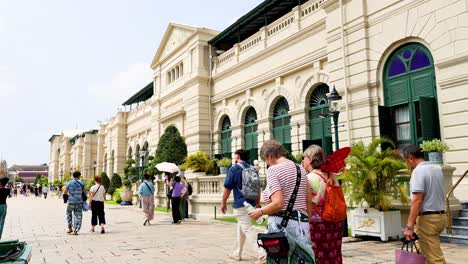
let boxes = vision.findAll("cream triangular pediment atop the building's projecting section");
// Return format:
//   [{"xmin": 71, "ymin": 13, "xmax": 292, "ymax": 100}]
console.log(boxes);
[{"xmin": 151, "ymin": 23, "xmax": 196, "ymax": 65}]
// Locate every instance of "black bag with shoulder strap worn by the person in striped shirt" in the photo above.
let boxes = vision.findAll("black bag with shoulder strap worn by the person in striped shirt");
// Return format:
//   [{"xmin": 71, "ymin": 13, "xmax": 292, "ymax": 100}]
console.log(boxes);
[{"xmin": 257, "ymin": 164, "xmax": 301, "ymax": 257}]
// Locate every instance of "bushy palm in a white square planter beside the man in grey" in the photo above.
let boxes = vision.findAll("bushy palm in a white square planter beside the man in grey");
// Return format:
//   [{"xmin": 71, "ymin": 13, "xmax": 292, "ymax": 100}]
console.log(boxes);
[{"xmin": 340, "ymin": 138, "xmax": 409, "ymax": 241}]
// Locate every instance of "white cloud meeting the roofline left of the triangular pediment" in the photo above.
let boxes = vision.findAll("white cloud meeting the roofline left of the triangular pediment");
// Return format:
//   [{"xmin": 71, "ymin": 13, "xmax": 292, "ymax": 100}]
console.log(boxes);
[{"xmin": 88, "ymin": 63, "xmax": 152, "ymax": 103}]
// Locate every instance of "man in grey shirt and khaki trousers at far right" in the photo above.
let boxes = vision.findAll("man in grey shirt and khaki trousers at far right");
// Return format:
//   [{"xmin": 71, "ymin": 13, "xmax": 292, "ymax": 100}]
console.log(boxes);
[{"xmin": 400, "ymin": 145, "xmax": 447, "ymax": 264}]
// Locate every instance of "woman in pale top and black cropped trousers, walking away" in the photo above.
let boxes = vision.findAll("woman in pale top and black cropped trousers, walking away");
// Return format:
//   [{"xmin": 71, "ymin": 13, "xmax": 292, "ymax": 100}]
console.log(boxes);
[{"xmin": 89, "ymin": 176, "xmax": 106, "ymax": 234}]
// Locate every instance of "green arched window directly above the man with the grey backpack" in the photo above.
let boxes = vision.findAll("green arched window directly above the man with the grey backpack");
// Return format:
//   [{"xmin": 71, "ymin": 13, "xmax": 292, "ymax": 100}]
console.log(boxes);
[{"xmin": 244, "ymin": 107, "xmax": 258, "ymax": 164}]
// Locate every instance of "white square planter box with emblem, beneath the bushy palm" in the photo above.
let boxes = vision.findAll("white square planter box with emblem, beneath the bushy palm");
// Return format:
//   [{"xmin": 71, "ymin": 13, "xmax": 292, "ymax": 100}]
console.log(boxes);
[{"xmin": 351, "ymin": 208, "xmax": 403, "ymax": 241}]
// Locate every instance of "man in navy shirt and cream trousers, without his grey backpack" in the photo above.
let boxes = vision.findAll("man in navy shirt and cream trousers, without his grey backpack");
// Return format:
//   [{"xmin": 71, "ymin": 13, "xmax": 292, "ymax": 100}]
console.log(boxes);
[{"xmin": 221, "ymin": 149, "xmax": 265, "ymax": 263}]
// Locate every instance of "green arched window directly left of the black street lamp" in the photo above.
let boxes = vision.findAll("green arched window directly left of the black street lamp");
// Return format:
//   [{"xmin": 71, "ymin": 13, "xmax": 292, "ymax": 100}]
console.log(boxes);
[{"xmin": 304, "ymin": 83, "xmax": 333, "ymax": 155}]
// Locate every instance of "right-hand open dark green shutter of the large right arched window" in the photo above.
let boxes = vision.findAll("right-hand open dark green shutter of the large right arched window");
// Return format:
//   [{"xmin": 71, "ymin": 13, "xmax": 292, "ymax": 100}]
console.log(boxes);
[{"xmin": 419, "ymin": 97, "xmax": 440, "ymax": 140}]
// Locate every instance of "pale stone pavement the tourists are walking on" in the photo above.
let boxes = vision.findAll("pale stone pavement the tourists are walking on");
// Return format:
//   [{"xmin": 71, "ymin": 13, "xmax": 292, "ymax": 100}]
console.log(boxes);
[{"xmin": 3, "ymin": 196, "xmax": 468, "ymax": 264}]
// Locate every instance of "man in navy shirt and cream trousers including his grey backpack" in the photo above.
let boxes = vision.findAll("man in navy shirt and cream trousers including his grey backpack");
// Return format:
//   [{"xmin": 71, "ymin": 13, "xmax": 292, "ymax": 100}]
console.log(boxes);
[{"xmin": 221, "ymin": 149, "xmax": 265, "ymax": 263}]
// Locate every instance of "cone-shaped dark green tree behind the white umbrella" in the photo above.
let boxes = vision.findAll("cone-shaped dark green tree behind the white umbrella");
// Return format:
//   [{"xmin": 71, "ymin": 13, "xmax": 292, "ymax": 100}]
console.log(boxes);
[{"xmin": 155, "ymin": 125, "xmax": 187, "ymax": 165}]
